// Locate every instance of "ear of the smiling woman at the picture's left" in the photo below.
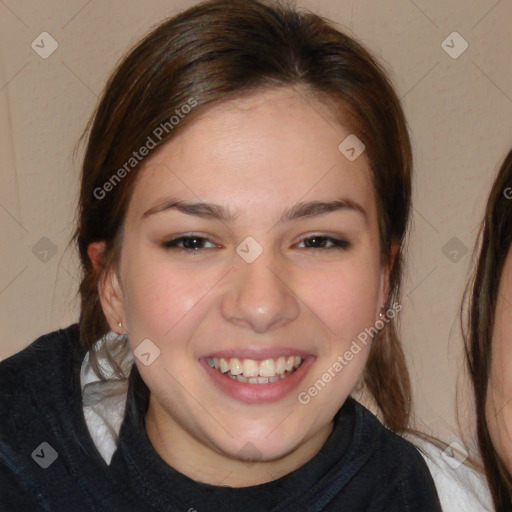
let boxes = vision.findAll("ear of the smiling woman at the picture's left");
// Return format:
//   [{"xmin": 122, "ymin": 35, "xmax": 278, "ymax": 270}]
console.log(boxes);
[{"xmin": 87, "ymin": 241, "xmax": 126, "ymax": 334}]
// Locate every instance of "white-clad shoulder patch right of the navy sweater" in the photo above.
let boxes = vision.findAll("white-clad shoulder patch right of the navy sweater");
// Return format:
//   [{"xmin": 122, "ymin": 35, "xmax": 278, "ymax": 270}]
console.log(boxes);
[{"xmin": 407, "ymin": 435, "xmax": 493, "ymax": 512}]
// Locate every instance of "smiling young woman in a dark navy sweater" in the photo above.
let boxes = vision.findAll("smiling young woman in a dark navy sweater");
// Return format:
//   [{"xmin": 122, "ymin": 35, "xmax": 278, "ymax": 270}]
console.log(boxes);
[{"xmin": 0, "ymin": 0, "xmax": 466, "ymax": 512}]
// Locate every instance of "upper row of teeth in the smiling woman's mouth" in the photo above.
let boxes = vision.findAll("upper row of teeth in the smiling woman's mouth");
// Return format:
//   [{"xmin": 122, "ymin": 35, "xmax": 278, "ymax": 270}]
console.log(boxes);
[{"xmin": 207, "ymin": 356, "xmax": 303, "ymax": 378}]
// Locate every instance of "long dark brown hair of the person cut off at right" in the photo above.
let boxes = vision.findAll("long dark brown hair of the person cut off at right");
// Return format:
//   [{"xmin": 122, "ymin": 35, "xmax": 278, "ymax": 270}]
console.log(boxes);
[{"xmin": 462, "ymin": 150, "xmax": 512, "ymax": 512}]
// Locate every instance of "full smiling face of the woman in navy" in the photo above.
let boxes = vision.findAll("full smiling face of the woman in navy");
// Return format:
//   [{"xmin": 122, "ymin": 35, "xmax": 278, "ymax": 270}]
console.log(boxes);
[{"xmin": 98, "ymin": 88, "xmax": 387, "ymax": 476}]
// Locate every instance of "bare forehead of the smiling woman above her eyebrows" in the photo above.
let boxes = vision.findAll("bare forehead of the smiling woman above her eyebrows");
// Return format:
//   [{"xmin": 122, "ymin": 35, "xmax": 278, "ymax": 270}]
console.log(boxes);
[{"xmin": 129, "ymin": 88, "xmax": 375, "ymax": 224}]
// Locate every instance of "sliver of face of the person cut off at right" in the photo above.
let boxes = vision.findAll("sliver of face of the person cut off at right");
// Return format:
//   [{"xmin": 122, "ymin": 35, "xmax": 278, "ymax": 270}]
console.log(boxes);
[{"xmin": 486, "ymin": 249, "xmax": 512, "ymax": 472}]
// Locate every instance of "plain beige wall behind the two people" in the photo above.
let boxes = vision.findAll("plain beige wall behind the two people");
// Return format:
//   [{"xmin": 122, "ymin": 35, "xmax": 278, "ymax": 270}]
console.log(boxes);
[{"xmin": 0, "ymin": 0, "xmax": 512, "ymax": 456}]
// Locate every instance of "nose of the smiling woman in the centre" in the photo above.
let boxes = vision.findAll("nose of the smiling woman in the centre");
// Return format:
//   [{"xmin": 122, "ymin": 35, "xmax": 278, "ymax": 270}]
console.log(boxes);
[{"xmin": 222, "ymin": 250, "xmax": 299, "ymax": 333}]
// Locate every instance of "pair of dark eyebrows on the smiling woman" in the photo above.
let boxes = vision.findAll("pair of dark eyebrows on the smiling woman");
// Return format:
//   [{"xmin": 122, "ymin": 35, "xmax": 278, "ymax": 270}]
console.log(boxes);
[{"xmin": 142, "ymin": 199, "xmax": 368, "ymax": 224}]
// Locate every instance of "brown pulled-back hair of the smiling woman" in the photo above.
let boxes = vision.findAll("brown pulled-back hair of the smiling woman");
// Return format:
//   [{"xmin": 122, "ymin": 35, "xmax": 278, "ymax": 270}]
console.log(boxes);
[{"xmin": 73, "ymin": 0, "xmax": 412, "ymax": 431}]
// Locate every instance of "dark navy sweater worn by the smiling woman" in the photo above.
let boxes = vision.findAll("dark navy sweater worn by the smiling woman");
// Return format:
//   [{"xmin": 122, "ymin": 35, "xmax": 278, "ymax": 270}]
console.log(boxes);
[{"xmin": 0, "ymin": 324, "xmax": 441, "ymax": 512}]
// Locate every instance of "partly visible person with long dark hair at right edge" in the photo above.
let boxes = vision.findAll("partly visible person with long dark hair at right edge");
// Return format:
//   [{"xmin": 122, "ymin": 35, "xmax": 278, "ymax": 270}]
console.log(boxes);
[{"xmin": 466, "ymin": 146, "xmax": 512, "ymax": 512}]
